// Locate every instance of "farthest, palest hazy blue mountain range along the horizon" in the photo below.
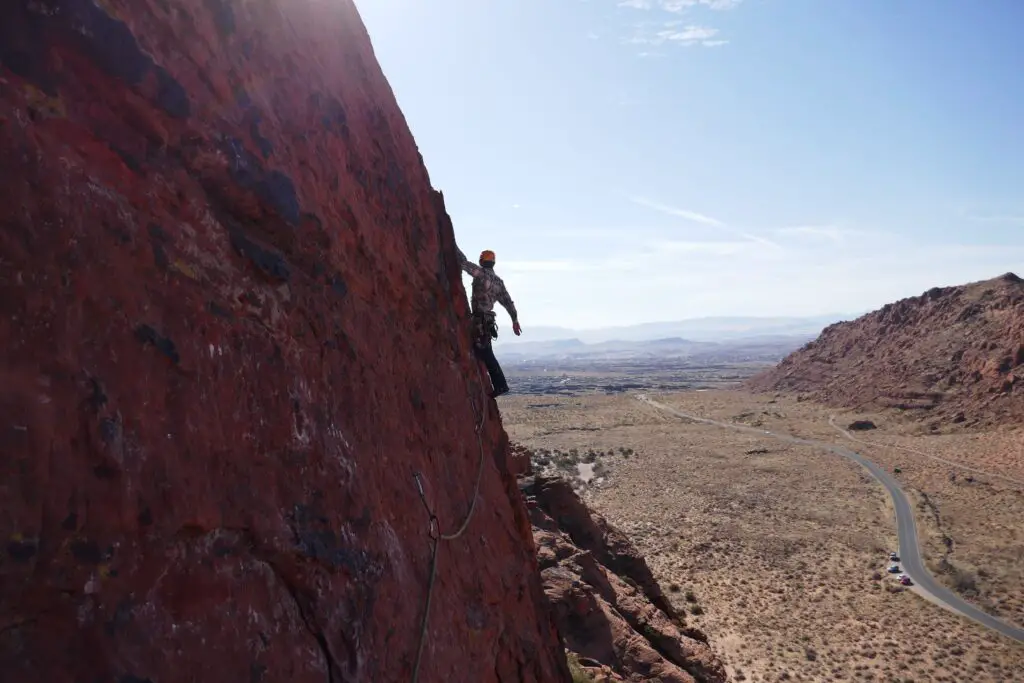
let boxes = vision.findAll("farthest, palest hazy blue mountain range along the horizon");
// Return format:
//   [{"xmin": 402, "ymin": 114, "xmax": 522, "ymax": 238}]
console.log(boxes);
[{"xmin": 495, "ymin": 313, "xmax": 859, "ymax": 351}]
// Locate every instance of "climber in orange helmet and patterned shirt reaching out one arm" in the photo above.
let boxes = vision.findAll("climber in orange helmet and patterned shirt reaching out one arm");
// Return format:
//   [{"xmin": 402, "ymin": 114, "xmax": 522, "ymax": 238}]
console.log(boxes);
[{"xmin": 456, "ymin": 247, "xmax": 522, "ymax": 398}]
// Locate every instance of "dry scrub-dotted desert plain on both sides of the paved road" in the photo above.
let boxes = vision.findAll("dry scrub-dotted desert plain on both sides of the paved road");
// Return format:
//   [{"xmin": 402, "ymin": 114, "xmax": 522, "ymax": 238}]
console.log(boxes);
[{"xmin": 501, "ymin": 391, "xmax": 1024, "ymax": 683}]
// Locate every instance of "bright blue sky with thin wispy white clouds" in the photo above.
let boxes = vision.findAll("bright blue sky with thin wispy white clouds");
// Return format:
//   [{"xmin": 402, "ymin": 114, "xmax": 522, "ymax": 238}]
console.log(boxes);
[{"xmin": 356, "ymin": 0, "xmax": 1024, "ymax": 335}]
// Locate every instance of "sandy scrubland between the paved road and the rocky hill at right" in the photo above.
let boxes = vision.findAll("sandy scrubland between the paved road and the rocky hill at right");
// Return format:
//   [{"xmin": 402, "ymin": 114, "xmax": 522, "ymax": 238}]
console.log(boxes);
[{"xmin": 669, "ymin": 391, "xmax": 1024, "ymax": 626}]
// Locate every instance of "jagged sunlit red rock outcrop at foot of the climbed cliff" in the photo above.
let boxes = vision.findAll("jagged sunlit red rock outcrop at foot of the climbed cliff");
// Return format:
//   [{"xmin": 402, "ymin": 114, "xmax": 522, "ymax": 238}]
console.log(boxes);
[{"xmin": 520, "ymin": 475, "xmax": 726, "ymax": 683}]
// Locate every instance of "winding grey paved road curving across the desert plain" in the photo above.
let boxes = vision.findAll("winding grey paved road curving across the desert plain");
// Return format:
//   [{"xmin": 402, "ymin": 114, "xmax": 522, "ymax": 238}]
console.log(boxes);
[{"xmin": 637, "ymin": 394, "xmax": 1024, "ymax": 642}]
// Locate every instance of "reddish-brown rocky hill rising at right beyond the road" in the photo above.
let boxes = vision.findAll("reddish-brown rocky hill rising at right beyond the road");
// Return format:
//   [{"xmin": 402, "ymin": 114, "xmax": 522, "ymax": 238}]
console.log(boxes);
[{"xmin": 748, "ymin": 273, "xmax": 1024, "ymax": 426}]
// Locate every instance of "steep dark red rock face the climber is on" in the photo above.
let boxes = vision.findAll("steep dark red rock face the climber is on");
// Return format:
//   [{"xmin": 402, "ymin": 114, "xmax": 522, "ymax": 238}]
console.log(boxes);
[{"xmin": 0, "ymin": 0, "xmax": 568, "ymax": 683}]
